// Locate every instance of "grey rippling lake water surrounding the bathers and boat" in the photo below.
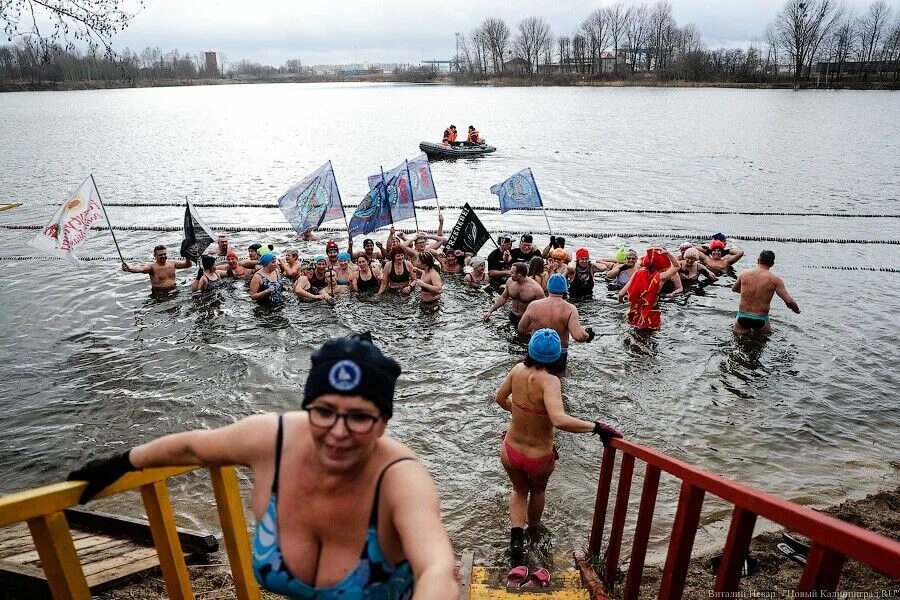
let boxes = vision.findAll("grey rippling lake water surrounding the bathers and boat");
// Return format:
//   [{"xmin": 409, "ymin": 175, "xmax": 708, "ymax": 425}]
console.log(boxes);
[{"xmin": 0, "ymin": 84, "xmax": 900, "ymax": 563}]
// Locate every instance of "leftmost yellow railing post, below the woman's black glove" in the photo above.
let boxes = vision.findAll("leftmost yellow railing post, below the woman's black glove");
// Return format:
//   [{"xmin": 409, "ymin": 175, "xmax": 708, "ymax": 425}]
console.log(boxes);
[{"xmin": 28, "ymin": 512, "xmax": 91, "ymax": 600}]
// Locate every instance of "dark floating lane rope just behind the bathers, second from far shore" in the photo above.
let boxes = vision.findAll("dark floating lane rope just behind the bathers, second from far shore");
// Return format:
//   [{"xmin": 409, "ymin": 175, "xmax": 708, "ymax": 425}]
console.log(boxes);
[{"xmin": 0, "ymin": 223, "xmax": 900, "ymax": 245}]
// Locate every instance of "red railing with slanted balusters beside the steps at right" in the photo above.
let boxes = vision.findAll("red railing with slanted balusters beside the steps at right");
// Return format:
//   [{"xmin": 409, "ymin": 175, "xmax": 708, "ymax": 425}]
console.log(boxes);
[{"xmin": 580, "ymin": 439, "xmax": 900, "ymax": 600}]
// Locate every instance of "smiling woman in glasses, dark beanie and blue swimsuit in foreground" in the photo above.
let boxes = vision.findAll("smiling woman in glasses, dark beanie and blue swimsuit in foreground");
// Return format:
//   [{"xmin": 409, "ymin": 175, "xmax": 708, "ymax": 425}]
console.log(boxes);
[{"xmin": 69, "ymin": 334, "xmax": 458, "ymax": 600}]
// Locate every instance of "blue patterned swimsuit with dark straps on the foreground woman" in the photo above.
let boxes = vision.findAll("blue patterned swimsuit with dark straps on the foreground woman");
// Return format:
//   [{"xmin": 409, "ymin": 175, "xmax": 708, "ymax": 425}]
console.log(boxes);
[{"xmin": 253, "ymin": 415, "xmax": 415, "ymax": 600}]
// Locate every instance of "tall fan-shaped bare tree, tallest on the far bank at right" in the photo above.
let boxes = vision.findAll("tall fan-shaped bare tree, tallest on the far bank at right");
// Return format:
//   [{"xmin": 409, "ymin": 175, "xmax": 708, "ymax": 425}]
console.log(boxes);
[{"xmin": 775, "ymin": 0, "xmax": 840, "ymax": 88}]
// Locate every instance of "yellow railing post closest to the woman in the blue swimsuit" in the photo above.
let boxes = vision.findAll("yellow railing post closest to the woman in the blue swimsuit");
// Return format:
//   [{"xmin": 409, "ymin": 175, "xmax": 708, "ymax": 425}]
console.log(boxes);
[{"xmin": 209, "ymin": 467, "xmax": 259, "ymax": 600}]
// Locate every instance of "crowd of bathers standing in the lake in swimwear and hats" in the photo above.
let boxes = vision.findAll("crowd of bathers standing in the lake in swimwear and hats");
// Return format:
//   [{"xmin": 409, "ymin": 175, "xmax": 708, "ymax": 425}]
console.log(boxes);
[{"xmin": 122, "ymin": 216, "xmax": 800, "ymax": 338}]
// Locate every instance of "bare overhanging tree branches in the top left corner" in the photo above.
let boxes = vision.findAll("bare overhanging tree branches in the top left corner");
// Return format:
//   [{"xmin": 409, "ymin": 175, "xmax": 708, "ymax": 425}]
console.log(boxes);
[{"xmin": 0, "ymin": 0, "xmax": 144, "ymax": 63}]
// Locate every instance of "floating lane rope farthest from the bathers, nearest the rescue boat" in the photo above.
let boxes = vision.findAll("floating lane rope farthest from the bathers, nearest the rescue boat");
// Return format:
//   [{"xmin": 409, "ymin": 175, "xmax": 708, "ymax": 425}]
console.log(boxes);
[{"xmin": 44, "ymin": 202, "xmax": 900, "ymax": 219}]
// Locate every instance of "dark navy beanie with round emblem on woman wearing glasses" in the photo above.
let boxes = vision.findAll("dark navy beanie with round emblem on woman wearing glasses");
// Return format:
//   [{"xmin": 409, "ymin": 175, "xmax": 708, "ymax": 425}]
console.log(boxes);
[{"xmin": 303, "ymin": 332, "xmax": 400, "ymax": 419}]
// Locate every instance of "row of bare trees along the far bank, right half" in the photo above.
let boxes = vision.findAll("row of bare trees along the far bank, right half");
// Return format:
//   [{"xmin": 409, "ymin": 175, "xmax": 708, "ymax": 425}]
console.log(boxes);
[{"xmin": 456, "ymin": 0, "xmax": 900, "ymax": 85}]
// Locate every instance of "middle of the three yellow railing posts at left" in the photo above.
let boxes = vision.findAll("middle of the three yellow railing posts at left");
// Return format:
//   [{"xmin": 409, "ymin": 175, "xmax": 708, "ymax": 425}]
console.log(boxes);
[{"xmin": 141, "ymin": 481, "xmax": 194, "ymax": 600}]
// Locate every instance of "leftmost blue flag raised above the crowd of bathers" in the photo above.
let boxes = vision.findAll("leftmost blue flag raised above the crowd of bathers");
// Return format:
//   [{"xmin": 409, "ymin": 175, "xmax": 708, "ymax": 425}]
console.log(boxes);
[{"xmin": 278, "ymin": 161, "xmax": 344, "ymax": 233}]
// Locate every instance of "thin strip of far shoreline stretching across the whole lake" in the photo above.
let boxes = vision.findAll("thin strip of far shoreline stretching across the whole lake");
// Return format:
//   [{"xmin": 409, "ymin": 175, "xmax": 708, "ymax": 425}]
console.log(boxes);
[{"xmin": 0, "ymin": 73, "xmax": 900, "ymax": 93}]
